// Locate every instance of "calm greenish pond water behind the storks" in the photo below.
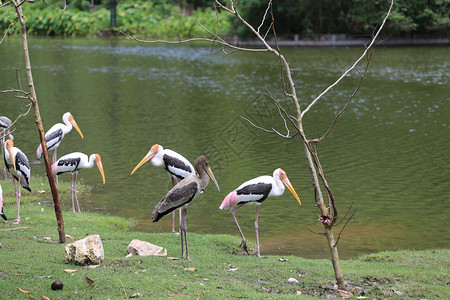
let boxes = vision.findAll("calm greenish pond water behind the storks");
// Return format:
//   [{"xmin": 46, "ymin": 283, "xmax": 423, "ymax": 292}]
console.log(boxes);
[{"xmin": 0, "ymin": 38, "xmax": 450, "ymax": 258}]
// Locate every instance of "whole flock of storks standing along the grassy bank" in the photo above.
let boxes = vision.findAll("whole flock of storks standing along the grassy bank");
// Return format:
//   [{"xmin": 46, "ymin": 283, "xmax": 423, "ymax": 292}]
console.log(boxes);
[{"xmin": 0, "ymin": 112, "xmax": 301, "ymax": 260}]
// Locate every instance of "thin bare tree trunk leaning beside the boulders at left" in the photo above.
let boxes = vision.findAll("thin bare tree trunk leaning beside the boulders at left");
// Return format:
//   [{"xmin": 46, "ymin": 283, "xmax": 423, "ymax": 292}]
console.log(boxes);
[{"xmin": 13, "ymin": 0, "xmax": 66, "ymax": 243}]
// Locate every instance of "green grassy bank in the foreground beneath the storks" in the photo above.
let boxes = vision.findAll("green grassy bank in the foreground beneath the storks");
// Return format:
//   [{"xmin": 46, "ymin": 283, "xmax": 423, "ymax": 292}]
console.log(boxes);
[{"xmin": 0, "ymin": 180, "xmax": 450, "ymax": 299}]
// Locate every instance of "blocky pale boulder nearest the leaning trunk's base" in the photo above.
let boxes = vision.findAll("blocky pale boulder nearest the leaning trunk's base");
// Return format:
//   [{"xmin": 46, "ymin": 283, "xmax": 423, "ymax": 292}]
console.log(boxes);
[{"xmin": 66, "ymin": 235, "xmax": 105, "ymax": 265}]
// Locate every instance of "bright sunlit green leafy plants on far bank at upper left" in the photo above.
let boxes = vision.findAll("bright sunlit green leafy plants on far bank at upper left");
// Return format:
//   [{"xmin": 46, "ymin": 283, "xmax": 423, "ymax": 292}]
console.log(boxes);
[{"xmin": 0, "ymin": 0, "xmax": 229, "ymax": 38}]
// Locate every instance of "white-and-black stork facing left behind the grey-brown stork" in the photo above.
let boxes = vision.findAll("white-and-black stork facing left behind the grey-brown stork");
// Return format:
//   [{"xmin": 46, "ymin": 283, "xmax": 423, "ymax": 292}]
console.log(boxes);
[{"xmin": 131, "ymin": 144, "xmax": 195, "ymax": 232}]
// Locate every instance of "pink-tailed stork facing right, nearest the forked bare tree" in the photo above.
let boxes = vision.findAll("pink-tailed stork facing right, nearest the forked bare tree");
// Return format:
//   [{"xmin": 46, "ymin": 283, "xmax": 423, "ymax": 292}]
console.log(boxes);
[{"xmin": 219, "ymin": 169, "xmax": 302, "ymax": 257}]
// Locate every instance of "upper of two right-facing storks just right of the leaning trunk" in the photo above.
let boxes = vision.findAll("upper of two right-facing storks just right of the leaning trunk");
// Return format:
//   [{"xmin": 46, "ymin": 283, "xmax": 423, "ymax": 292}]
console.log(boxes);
[{"xmin": 36, "ymin": 112, "xmax": 83, "ymax": 163}]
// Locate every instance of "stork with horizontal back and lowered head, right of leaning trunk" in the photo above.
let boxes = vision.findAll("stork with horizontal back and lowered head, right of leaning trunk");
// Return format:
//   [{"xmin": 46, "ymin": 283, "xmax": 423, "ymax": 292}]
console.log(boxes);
[{"xmin": 52, "ymin": 152, "xmax": 105, "ymax": 213}]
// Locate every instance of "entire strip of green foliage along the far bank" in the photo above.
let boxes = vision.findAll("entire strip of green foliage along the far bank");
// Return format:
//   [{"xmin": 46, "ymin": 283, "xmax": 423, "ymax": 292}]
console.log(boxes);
[{"xmin": 0, "ymin": 0, "xmax": 450, "ymax": 38}]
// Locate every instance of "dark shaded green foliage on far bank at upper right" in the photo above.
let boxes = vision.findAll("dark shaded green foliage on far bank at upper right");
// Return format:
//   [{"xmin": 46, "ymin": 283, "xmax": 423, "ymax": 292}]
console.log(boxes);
[{"xmin": 240, "ymin": 0, "xmax": 450, "ymax": 36}]
